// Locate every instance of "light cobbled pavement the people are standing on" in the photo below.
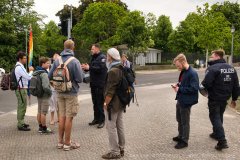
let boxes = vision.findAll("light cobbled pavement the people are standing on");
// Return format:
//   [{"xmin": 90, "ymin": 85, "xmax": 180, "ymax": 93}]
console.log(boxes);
[{"xmin": 0, "ymin": 84, "xmax": 240, "ymax": 160}]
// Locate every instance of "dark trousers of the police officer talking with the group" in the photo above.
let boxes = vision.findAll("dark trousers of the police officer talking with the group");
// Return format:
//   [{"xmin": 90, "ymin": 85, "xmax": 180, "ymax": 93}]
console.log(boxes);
[{"xmin": 91, "ymin": 87, "xmax": 105, "ymax": 123}]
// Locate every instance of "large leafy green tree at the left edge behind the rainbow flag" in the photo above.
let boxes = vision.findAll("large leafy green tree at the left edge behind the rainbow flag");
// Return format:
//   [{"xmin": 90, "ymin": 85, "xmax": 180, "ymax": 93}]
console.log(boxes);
[{"xmin": 0, "ymin": 0, "xmax": 42, "ymax": 71}]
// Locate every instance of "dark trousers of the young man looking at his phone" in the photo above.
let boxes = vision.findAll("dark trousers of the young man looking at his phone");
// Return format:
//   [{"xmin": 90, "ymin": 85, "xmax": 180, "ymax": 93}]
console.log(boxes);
[{"xmin": 176, "ymin": 102, "xmax": 191, "ymax": 143}]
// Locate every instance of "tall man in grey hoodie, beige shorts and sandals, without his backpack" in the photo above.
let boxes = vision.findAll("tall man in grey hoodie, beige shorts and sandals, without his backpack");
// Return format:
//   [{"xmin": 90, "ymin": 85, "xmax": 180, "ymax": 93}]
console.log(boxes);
[{"xmin": 48, "ymin": 40, "xmax": 83, "ymax": 151}]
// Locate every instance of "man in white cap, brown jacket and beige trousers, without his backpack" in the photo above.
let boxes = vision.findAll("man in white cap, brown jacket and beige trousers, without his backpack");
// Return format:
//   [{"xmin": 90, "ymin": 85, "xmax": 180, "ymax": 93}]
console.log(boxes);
[{"xmin": 102, "ymin": 48, "xmax": 125, "ymax": 159}]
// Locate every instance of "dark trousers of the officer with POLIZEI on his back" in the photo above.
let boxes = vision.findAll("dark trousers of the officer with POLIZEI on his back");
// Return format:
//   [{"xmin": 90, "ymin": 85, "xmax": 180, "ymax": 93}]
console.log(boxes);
[{"xmin": 208, "ymin": 100, "xmax": 227, "ymax": 140}]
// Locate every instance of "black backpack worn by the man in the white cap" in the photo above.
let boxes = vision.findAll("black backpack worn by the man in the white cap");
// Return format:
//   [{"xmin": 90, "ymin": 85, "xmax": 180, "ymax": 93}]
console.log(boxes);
[{"xmin": 116, "ymin": 65, "xmax": 135, "ymax": 109}]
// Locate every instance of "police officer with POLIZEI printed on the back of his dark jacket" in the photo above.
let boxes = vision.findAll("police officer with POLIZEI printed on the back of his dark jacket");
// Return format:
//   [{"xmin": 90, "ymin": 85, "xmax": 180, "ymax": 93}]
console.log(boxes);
[{"xmin": 202, "ymin": 50, "xmax": 239, "ymax": 150}]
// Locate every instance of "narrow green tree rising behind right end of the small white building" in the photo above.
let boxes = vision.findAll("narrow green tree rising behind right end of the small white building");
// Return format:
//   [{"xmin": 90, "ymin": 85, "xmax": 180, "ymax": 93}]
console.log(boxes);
[{"xmin": 153, "ymin": 15, "xmax": 173, "ymax": 52}]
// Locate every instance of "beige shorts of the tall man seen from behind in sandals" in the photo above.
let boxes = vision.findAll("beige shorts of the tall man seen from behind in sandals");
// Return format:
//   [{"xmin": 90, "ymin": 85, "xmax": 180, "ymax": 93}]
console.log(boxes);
[{"xmin": 57, "ymin": 94, "xmax": 79, "ymax": 117}]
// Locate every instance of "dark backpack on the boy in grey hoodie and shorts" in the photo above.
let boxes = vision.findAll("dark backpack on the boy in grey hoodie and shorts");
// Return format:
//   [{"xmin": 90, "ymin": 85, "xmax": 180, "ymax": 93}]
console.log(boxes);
[{"xmin": 29, "ymin": 71, "xmax": 45, "ymax": 98}]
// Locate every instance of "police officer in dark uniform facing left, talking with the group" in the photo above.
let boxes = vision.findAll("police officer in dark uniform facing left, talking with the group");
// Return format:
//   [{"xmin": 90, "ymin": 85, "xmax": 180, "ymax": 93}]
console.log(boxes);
[{"xmin": 82, "ymin": 44, "xmax": 107, "ymax": 128}]
